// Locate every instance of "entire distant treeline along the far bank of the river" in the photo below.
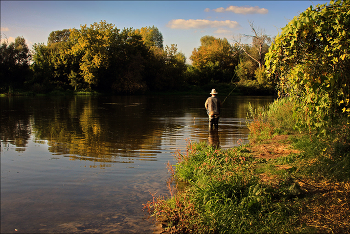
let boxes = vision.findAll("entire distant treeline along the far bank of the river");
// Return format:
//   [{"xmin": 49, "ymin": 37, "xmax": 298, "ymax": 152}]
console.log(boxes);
[{"xmin": 0, "ymin": 21, "xmax": 275, "ymax": 94}]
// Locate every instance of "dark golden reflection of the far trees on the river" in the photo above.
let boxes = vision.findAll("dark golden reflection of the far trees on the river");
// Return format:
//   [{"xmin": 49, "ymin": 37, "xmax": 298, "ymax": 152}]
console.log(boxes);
[{"xmin": 0, "ymin": 96, "xmax": 274, "ymax": 167}]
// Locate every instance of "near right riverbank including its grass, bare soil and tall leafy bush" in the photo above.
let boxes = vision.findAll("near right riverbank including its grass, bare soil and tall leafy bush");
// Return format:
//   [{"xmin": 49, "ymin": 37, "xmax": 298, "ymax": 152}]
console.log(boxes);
[{"xmin": 145, "ymin": 1, "xmax": 350, "ymax": 233}]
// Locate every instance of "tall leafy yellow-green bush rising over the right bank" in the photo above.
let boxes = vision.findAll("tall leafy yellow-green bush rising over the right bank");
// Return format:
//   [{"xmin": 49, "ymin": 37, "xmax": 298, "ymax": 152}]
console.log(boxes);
[{"xmin": 266, "ymin": 0, "xmax": 350, "ymax": 133}]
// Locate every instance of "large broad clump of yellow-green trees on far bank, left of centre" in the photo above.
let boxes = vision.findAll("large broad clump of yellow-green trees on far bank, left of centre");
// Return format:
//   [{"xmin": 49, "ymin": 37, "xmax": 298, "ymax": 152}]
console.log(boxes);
[{"xmin": 29, "ymin": 21, "xmax": 186, "ymax": 94}]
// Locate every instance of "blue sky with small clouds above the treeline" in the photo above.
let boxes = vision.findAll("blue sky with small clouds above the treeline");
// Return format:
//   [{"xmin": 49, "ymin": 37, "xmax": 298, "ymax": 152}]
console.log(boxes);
[{"xmin": 0, "ymin": 0, "xmax": 329, "ymax": 62}]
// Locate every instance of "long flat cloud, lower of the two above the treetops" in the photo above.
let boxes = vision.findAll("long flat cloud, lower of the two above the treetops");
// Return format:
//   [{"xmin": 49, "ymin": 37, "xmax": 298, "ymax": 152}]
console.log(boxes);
[{"xmin": 167, "ymin": 19, "xmax": 239, "ymax": 29}]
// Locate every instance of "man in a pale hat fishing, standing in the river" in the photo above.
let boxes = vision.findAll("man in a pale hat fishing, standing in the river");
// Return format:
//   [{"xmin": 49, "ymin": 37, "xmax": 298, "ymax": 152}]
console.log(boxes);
[{"xmin": 204, "ymin": 89, "xmax": 221, "ymax": 129}]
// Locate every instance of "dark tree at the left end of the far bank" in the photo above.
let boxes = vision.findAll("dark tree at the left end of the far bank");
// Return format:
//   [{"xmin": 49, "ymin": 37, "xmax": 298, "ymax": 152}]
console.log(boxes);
[{"xmin": 0, "ymin": 37, "xmax": 31, "ymax": 91}]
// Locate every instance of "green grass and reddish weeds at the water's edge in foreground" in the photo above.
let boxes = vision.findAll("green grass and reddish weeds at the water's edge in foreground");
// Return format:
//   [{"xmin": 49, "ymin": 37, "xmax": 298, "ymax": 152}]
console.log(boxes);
[{"xmin": 144, "ymin": 143, "xmax": 300, "ymax": 233}]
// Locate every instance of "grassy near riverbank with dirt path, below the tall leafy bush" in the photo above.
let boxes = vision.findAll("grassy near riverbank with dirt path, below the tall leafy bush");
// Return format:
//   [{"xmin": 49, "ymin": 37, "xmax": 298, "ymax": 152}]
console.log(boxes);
[{"xmin": 145, "ymin": 96, "xmax": 350, "ymax": 233}]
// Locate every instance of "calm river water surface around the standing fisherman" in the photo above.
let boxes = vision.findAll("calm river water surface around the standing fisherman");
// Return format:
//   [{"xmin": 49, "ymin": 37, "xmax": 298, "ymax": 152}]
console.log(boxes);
[{"xmin": 0, "ymin": 96, "xmax": 273, "ymax": 233}]
